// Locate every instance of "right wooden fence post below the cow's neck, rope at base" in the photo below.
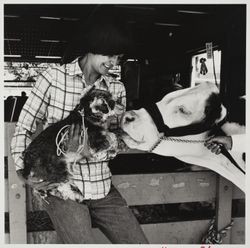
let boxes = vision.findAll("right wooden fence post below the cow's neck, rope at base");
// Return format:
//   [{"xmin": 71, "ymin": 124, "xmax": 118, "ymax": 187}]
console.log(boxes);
[{"xmin": 216, "ymin": 175, "xmax": 233, "ymax": 244}]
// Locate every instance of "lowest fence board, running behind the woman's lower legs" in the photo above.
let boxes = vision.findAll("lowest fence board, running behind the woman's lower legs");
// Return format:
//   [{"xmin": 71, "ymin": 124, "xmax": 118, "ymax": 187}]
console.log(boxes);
[{"xmin": 25, "ymin": 218, "xmax": 245, "ymax": 244}]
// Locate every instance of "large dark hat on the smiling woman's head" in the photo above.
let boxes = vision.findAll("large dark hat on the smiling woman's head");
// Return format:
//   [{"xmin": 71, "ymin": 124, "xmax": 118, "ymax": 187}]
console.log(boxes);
[{"xmin": 62, "ymin": 13, "xmax": 133, "ymax": 64}]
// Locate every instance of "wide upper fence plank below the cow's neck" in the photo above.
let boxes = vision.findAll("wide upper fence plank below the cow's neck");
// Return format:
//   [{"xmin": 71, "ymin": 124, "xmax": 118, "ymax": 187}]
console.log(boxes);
[{"xmin": 112, "ymin": 172, "xmax": 216, "ymax": 205}]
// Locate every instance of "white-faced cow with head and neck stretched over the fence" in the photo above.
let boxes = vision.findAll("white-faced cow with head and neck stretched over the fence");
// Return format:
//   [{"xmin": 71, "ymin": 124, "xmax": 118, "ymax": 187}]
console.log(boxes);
[{"xmin": 121, "ymin": 82, "xmax": 245, "ymax": 191}]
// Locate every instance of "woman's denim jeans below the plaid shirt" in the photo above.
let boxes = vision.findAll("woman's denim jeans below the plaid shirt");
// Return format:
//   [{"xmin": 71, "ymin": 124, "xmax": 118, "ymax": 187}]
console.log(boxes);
[{"xmin": 44, "ymin": 186, "xmax": 148, "ymax": 244}]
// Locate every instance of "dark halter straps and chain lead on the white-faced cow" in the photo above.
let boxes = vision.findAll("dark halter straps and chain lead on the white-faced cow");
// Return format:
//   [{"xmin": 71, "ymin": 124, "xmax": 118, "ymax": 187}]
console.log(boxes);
[{"xmin": 143, "ymin": 103, "xmax": 246, "ymax": 174}]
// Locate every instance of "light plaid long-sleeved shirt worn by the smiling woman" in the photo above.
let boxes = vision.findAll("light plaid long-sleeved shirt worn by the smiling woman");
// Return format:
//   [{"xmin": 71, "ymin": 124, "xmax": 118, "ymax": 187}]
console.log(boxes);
[{"xmin": 11, "ymin": 59, "xmax": 126, "ymax": 199}]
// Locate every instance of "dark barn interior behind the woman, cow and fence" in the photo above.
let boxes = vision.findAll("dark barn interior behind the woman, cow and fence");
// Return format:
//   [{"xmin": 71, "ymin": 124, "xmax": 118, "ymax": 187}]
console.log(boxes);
[{"xmin": 4, "ymin": 4, "xmax": 246, "ymax": 243}]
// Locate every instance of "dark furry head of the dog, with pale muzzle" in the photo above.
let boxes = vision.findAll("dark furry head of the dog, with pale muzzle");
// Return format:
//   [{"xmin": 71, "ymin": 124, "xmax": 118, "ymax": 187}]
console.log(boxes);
[{"xmin": 75, "ymin": 87, "xmax": 115, "ymax": 127}]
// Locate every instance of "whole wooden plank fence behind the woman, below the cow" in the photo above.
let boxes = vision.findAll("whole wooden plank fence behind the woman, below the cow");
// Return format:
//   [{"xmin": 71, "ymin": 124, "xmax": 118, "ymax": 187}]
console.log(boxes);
[{"xmin": 5, "ymin": 123, "xmax": 245, "ymax": 244}]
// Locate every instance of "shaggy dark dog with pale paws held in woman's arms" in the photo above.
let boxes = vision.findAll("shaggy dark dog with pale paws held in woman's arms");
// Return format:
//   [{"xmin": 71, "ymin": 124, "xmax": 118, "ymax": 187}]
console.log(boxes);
[{"xmin": 23, "ymin": 87, "xmax": 118, "ymax": 201}]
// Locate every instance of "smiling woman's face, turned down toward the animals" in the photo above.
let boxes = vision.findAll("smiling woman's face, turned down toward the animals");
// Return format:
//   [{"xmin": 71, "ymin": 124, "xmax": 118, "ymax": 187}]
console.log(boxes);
[{"xmin": 90, "ymin": 54, "xmax": 123, "ymax": 75}]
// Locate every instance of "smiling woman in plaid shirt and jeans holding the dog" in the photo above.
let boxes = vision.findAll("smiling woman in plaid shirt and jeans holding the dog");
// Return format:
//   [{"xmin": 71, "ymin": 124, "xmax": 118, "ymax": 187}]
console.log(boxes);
[{"xmin": 11, "ymin": 12, "xmax": 148, "ymax": 244}]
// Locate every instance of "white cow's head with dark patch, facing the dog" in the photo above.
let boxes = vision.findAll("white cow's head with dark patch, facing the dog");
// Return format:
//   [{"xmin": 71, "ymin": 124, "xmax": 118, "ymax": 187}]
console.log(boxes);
[{"xmin": 121, "ymin": 82, "xmax": 226, "ymax": 150}]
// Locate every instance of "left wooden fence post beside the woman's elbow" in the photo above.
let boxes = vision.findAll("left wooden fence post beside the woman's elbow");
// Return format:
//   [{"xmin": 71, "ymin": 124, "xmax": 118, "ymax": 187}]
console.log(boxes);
[{"xmin": 5, "ymin": 123, "xmax": 27, "ymax": 244}]
